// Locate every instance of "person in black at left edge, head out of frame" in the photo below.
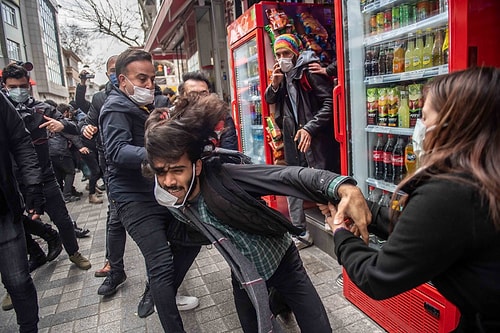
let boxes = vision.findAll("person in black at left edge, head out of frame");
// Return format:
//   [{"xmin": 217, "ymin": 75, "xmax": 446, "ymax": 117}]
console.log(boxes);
[{"xmin": 0, "ymin": 92, "xmax": 44, "ymax": 332}]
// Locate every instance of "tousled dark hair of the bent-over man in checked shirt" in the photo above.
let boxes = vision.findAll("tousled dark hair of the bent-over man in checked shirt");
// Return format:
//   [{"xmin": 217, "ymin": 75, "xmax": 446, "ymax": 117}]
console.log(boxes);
[{"xmin": 145, "ymin": 94, "xmax": 229, "ymax": 165}]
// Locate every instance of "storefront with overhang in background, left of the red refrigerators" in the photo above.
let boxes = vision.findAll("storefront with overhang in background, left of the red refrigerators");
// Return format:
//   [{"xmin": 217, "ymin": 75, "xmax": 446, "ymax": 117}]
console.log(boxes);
[{"xmin": 144, "ymin": 0, "xmax": 230, "ymax": 101}]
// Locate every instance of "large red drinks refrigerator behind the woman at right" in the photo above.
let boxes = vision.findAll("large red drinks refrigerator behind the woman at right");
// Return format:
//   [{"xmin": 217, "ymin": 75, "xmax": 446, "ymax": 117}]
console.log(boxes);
[{"xmin": 334, "ymin": 0, "xmax": 500, "ymax": 332}]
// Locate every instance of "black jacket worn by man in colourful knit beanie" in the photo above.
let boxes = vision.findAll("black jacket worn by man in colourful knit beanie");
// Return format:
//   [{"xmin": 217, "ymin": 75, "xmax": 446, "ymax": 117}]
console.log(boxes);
[{"xmin": 264, "ymin": 51, "xmax": 340, "ymax": 172}]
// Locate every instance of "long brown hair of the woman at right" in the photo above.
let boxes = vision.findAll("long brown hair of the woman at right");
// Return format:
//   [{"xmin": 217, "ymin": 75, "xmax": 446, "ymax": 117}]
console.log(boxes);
[{"xmin": 398, "ymin": 67, "xmax": 500, "ymax": 230}]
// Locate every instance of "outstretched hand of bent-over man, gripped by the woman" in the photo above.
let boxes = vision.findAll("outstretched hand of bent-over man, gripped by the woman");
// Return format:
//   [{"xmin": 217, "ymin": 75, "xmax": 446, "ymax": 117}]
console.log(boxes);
[{"xmin": 327, "ymin": 184, "xmax": 372, "ymax": 244}]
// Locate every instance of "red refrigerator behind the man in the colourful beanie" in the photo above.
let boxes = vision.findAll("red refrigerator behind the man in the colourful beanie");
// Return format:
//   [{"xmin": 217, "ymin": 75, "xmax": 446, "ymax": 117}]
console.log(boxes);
[{"xmin": 227, "ymin": 1, "xmax": 335, "ymax": 211}]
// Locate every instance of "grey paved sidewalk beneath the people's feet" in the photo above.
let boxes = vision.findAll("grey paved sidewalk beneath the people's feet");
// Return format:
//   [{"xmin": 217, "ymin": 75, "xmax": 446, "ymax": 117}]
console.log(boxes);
[{"xmin": 0, "ymin": 173, "xmax": 385, "ymax": 333}]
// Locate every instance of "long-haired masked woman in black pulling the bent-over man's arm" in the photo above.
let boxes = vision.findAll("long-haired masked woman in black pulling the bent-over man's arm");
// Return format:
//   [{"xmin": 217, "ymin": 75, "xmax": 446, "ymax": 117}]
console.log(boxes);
[{"xmin": 324, "ymin": 67, "xmax": 500, "ymax": 333}]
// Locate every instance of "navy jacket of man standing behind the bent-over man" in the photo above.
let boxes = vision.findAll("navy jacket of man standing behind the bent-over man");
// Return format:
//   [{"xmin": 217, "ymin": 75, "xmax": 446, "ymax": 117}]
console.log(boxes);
[{"xmin": 99, "ymin": 89, "xmax": 151, "ymax": 202}]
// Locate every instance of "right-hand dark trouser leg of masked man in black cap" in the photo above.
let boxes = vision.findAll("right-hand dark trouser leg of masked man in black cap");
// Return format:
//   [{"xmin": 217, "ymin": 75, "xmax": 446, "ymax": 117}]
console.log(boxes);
[{"xmin": 43, "ymin": 177, "xmax": 78, "ymax": 256}]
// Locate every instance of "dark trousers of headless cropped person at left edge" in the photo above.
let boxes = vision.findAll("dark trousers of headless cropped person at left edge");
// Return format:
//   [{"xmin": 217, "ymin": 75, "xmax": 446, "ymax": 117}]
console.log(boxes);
[{"xmin": 0, "ymin": 212, "xmax": 38, "ymax": 332}]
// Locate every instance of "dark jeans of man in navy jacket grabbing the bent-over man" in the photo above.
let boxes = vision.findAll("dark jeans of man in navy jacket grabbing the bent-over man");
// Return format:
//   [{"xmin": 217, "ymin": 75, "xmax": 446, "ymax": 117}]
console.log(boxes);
[{"xmin": 116, "ymin": 201, "xmax": 201, "ymax": 333}]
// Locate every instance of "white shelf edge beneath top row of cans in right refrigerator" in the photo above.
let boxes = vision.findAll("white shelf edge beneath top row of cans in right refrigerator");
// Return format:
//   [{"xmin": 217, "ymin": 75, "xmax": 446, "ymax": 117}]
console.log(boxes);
[{"xmin": 363, "ymin": 13, "xmax": 448, "ymax": 46}]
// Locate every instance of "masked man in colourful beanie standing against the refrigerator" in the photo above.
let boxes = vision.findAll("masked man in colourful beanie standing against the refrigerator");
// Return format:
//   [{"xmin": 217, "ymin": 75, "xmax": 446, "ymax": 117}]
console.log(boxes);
[{"xmin": 264, "ymin": 34, "xmax": 340, "ymax": 249}]
